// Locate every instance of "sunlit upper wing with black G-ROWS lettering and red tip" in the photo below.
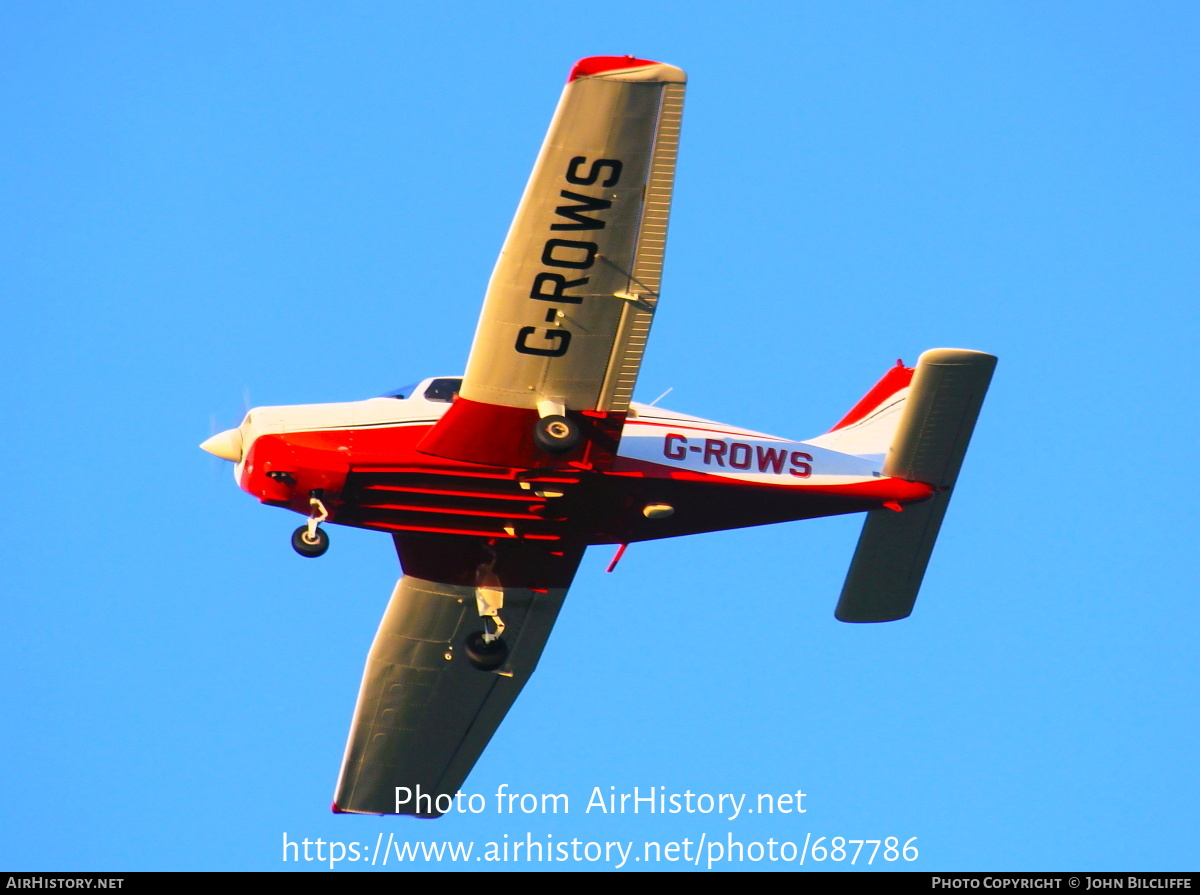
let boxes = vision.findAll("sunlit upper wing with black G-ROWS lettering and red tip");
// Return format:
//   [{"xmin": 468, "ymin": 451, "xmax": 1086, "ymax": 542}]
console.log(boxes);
[{"xmin": 421, "ymin": 56, "xmax": 686, "ymax": 467}]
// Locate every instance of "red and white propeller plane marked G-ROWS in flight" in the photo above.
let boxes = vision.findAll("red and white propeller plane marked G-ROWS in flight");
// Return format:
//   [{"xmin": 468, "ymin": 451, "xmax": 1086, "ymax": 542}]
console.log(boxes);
[{"xmin": 202, "ymin": 56, "xmax": 996, "ymax": 817}]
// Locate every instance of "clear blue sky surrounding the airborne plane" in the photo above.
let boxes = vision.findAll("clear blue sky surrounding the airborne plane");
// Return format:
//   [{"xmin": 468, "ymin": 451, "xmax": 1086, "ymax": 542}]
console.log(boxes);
[{"xmin": 0, "ymin": 2, "xmax": 1200, "ymax": 872}]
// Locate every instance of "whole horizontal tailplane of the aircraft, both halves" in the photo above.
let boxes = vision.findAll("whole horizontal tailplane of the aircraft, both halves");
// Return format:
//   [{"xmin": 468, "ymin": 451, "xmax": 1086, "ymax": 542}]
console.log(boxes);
[{"xmin": 834, "ymin": 348, "xmax": 996, "ymax": 621}]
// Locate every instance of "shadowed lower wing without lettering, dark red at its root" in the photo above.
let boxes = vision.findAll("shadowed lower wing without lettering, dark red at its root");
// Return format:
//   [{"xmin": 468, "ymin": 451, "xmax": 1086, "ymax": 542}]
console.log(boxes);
[{"xmin": 334, "ymin": 533, "xmax": 583, "ymax": 817}]
